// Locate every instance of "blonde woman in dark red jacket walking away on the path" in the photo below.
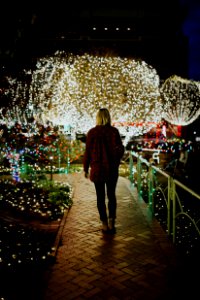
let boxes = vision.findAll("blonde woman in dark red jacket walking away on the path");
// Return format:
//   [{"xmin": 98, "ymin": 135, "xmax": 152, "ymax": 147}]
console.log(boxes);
[{"xmin": 83, "ymin": 108, "xmax": 124, "ymax": 233}]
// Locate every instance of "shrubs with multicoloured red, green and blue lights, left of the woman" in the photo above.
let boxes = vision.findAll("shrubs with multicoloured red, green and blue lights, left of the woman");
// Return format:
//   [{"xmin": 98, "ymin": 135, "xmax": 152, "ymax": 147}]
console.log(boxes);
[{"xmin": 0, "ymin": 124, "xmax": 84, "ymax": 179}]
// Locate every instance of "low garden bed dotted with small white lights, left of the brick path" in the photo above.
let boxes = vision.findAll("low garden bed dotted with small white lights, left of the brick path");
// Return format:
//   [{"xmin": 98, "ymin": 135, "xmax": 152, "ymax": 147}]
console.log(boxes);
[{"xmin": 0, "ymin": 173, "xmax": 72, "ymax": 271}]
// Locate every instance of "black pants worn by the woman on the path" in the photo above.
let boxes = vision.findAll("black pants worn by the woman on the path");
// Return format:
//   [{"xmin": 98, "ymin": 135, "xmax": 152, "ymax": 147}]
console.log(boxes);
[{"xmin": 94, "ymin": 177, "xmax": 118, "ymax": 221}]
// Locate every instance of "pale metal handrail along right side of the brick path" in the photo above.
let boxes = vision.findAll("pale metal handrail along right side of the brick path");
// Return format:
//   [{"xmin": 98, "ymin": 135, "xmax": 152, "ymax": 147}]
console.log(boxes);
[{"xmin": 129, "ymin": 151, "xmax": 200, "ymax": 253}]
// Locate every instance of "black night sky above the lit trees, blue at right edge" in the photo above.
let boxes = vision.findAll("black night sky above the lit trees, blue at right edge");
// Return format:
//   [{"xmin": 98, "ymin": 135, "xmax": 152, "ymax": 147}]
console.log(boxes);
[{"xmin": 0, "ymin": 0, "xmax": 200, "ymax": 80}]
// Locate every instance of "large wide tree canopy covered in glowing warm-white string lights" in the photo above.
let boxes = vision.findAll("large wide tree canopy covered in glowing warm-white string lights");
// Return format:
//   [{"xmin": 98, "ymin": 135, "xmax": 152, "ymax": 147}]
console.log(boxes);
[{"xmin": 0, "ymin": 51, "xmax": 162, "ymax": 141}]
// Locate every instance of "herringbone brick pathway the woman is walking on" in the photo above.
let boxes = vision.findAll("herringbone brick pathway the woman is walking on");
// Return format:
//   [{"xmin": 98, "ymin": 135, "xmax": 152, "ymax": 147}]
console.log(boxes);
[{"xmin": 41, "ymin": 173, "xmax": 198, "ymax": 300}]
